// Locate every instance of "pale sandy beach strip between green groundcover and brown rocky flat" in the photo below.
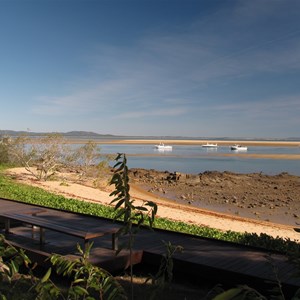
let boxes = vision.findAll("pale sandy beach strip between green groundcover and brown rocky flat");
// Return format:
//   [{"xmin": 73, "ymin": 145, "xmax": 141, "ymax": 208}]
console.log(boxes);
[{"xmin": 4, "ymin": 168, "xmax": 300, "ymax": 241}]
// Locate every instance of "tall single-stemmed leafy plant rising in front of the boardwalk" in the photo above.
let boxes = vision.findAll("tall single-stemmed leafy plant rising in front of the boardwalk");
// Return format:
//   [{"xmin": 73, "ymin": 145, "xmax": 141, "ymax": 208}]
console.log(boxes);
[{"xmin": 110, "ymin": 153, "xmax": 157, "ymax": 297}]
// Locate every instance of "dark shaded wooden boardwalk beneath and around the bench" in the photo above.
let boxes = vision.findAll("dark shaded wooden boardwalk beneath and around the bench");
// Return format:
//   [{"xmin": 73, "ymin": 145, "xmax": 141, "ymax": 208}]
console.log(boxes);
[{"xmin": 0, "ymin": 198, "xmax": 300, "ymax": 293}]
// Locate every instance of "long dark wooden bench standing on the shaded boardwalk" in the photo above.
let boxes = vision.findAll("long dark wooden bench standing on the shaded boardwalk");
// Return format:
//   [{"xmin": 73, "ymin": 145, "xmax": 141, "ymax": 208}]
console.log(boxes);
[{"xmin": 0, "ymin": 212, "xmax": 118, "ymax": 250}]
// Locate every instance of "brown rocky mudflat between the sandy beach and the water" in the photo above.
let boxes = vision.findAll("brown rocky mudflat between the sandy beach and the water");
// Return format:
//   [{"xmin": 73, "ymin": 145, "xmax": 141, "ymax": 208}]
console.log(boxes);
[{"xmin": 130, "ymin": 169, "xmax": 300, "ymax": 226}]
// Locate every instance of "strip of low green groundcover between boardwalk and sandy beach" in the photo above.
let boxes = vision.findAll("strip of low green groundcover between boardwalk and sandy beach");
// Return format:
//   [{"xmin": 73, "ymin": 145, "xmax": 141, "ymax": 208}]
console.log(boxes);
[{"xmin": 0, "ymin": 165, "xmax": 300, "ymax": 254}]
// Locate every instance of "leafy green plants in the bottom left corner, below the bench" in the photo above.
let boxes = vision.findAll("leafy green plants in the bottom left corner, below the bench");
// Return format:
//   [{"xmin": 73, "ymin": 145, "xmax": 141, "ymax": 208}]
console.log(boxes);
[{"xmin": 0, "ymin": 235, "xmax": 126, "ymax": 300}]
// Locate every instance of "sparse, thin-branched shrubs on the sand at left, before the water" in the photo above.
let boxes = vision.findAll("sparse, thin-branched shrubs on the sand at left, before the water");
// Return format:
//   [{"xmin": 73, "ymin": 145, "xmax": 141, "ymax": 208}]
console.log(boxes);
[{"xmin": 5, "ymin": 134, "xmax": 110, "ymax": 181}]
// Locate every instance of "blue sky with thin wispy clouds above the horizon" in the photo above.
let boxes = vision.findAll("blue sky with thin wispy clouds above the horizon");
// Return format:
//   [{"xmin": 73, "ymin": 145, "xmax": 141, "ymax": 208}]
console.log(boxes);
[{"xmin": 0, "ymin": 0, "xmax": 300, "ymax": 138}]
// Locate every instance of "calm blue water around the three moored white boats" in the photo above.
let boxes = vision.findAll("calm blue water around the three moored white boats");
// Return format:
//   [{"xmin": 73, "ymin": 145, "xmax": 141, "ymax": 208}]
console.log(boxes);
[{"xmin": 91, "ymin": 144, "xmax": 300, "ymax": 176}]
